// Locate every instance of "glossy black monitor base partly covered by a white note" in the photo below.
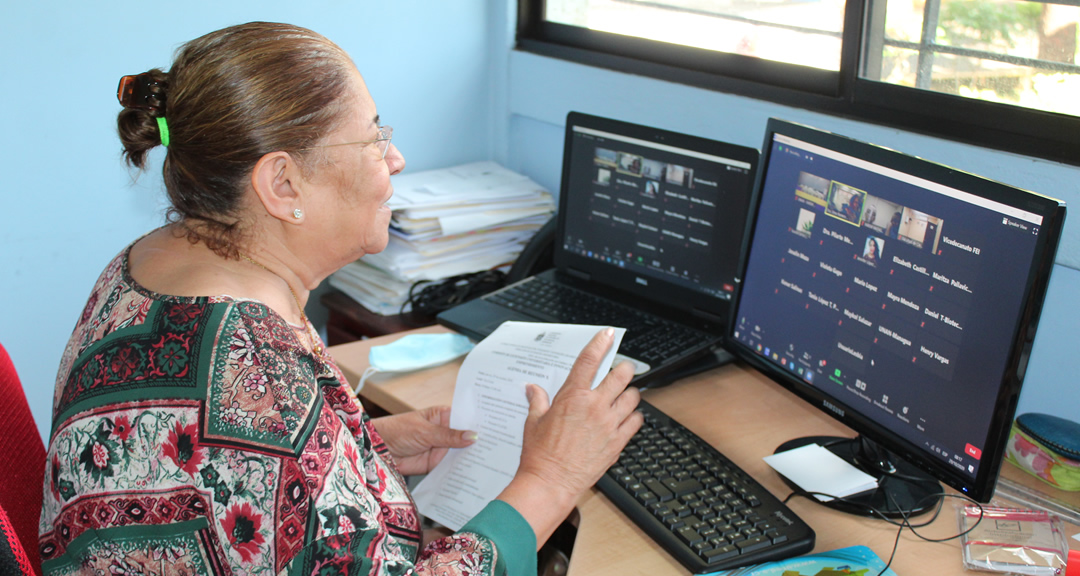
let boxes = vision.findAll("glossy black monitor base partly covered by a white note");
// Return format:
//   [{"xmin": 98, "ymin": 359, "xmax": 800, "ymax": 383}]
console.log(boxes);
[{"xmin": 777, "ymin": 436, "xmax": 944, "ymax": 518}]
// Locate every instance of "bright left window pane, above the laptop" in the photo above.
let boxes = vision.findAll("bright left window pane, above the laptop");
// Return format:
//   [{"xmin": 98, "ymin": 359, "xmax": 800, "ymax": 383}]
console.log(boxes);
[{"xmin": 544, "ymin": 0, "xmax": 843, "ymax": 71}]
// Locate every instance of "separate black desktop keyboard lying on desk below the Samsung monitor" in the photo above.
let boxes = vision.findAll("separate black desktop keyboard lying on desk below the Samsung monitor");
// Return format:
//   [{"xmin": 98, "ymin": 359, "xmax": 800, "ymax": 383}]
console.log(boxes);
[{"xmin": 596, "ymin": 401, "xmax": 814, "ymax": 574}]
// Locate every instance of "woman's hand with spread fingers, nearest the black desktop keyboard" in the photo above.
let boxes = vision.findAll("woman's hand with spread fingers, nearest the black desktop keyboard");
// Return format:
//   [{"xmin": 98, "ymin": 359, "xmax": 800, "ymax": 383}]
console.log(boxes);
[{"xmin": 499, "ymin": 329, "xmax": 643, "ymax": 547}]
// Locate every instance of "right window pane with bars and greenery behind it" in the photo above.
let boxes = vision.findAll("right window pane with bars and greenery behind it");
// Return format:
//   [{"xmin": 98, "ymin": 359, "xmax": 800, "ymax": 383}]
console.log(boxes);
[{"xmin": 862, "ymin": 0, "xmax": 1080, "ymax": 116}]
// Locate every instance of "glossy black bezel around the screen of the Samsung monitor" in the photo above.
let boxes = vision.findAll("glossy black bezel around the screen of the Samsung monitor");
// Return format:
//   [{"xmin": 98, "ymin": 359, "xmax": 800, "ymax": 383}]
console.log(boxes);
[{"xmin": 725, "ymin": 118, "xmax": 1065, "ymax": 503}]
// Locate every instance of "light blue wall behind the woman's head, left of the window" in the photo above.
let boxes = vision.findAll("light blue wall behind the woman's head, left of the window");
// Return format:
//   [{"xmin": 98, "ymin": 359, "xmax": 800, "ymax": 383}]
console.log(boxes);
[{"xmin": 0, "ymin": 0, "xmax": 494, "ymax": 436}]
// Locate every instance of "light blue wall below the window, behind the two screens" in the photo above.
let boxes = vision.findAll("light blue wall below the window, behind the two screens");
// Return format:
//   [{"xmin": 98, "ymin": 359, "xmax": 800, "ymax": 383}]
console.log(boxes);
[{"xmin": 504, "ymin": 52, "xmax": 1080, "ymax": 420}]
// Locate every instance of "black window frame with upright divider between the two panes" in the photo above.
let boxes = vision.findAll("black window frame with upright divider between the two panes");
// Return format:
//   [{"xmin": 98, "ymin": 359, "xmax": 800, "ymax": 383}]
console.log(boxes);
[{"xmin": 516, "ymin": 0, "xmax": 1080, "ymax": 165}]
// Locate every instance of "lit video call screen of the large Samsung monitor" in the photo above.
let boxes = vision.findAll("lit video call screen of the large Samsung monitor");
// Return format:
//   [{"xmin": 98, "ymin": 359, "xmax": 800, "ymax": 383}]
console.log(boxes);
[{"xmin": 733, "ymin": 134, "xmax": 1041, "ymax": 478}]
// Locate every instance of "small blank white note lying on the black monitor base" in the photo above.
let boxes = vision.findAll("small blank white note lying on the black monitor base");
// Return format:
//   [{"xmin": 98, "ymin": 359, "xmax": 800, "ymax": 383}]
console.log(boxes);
[{"xmin": 765, "ymin": 444, "xmax": 877, "ymax": 501}]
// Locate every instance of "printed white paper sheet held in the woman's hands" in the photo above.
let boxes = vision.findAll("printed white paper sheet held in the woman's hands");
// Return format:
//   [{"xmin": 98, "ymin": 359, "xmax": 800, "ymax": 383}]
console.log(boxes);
[{"xmin": 413, "ymin": 322, "xmax": 625, "ymax": 530}]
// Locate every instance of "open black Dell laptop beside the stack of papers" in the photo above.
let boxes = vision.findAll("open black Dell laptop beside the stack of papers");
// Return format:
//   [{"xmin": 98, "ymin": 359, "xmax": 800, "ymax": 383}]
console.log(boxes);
[{"xmin": 437, "ymin": 112, "xmax": 758, "ymax": 386}]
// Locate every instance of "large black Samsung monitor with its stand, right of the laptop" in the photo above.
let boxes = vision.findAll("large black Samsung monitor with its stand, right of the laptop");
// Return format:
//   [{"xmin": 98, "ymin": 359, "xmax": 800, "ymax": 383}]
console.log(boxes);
[{"xmin": 728, "ymin": 119, "xmax": 1065, "ymax": 515}]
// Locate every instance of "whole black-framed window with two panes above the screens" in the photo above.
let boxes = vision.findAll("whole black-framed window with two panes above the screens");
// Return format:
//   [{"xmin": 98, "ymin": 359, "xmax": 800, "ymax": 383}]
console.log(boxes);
[{"xmin": 518, "ymin": 0, "xmax": 1080, "ymax": 164}]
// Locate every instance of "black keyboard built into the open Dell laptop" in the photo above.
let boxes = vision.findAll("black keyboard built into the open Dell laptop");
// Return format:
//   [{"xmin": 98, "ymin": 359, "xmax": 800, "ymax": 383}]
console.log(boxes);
[{"xmin": 485, "ymin": 278, "xmax": 716, "ymax": 366}]
